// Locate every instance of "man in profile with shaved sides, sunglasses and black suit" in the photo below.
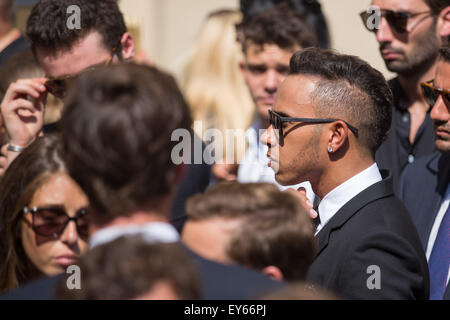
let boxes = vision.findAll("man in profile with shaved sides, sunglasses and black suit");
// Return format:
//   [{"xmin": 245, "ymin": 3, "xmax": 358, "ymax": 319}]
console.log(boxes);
[{"xmin": 263, "ymin": 48, "xmax": 429, "ymax": 299}]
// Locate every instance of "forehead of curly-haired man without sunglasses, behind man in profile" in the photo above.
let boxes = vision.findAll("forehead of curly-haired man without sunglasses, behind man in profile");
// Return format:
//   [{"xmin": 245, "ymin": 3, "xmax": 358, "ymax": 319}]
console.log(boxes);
[{"xmin": 245, "ymin": 44, "xmax": 297, "ymax": 64}]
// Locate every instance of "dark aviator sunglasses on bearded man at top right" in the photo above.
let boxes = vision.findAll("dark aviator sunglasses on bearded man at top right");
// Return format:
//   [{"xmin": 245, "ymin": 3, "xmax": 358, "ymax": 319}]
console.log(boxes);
[{"xmin": 359, "ymin": 9, "xmax": 433, "ymax": 33}]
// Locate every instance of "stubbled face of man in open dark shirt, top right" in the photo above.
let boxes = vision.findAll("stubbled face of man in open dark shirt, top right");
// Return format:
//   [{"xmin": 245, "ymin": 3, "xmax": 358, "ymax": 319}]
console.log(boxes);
[{"xmin": 372, "ymin": 0, "xmax": 441, "ymax": 74}]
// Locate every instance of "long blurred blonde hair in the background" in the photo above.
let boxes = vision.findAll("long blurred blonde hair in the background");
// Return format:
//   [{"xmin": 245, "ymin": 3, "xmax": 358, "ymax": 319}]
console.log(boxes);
[{"xmin": 181, "ymin": 10, "xmax": 254, "ymax": 158}]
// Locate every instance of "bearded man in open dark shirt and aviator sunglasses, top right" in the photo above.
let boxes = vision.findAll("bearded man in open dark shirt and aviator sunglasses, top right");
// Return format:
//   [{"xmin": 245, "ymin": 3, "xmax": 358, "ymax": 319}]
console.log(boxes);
[{"xmin": 360, "ymin": 0, "xmax": 450, "ymax": 191}]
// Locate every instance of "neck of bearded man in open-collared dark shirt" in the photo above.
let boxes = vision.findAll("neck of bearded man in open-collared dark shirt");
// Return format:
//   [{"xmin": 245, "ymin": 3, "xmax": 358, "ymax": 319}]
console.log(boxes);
[{"xmin": 398, "ymin": 57, "xmax": 437, "ymax": 110}]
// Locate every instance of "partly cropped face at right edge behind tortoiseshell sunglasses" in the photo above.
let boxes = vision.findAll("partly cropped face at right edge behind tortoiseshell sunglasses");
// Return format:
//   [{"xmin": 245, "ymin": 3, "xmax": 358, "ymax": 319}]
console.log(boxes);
[{"xmin": 430, "ymin": 61, "xmax": 450, "ymax": 152}]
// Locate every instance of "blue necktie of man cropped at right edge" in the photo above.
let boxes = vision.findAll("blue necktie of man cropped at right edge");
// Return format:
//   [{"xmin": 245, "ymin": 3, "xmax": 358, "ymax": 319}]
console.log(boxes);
[{"xmin": 428, "ymin": 205, "xmax": 450, "ymax": 300}]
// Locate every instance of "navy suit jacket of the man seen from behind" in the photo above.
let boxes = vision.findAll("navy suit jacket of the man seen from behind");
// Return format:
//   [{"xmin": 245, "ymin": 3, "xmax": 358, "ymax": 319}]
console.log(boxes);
[{"xmin": 0, "ymin": 244, "xmax": 284, "ymax": 300}]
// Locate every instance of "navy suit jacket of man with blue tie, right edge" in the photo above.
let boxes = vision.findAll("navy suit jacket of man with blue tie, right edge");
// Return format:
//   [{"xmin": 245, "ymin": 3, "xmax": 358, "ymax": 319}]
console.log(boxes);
[{"xmin": 400, "ymin": 152, "xmax": 450, "ymax": 300}]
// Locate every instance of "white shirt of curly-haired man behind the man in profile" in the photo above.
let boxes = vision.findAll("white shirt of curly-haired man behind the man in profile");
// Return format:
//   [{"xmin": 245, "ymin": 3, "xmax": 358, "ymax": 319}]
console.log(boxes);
[{"xmin": 237, "ymin": 120, "xmax": 314, "ymax": 202}]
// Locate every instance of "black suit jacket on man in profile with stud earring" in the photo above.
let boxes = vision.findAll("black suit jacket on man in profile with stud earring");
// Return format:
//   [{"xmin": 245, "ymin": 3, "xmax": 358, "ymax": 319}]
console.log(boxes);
[{"xmin": 308, "ymin": 171, "xmax": 429, "ymax": 299}]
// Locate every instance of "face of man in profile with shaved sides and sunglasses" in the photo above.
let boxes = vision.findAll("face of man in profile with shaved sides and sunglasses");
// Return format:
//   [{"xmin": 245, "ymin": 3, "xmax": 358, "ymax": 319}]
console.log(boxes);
[{"xmin": 261, "ymin": 75, "xmax": 327, "ymax": 185}]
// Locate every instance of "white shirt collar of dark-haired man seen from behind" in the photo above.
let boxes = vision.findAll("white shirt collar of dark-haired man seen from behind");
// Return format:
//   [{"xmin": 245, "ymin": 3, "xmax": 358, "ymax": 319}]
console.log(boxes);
[{"xmin": 89, "ymin": 222, "xmax": 180, "ymax": 249}]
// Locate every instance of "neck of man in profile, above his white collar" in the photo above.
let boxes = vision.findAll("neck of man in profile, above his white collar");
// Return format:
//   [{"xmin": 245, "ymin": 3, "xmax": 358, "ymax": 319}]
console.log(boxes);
[{"xmin": 311, "ymin": 158, "xmax": 375, "ymax": 199}]
